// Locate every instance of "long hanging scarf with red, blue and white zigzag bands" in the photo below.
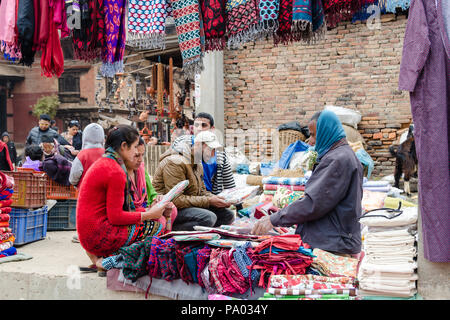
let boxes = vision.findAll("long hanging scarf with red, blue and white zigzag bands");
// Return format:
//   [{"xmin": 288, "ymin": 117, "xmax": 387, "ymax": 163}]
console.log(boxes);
[{"xmin": 172, "ymin": 0, "xmax": 204, "ymax": 80}]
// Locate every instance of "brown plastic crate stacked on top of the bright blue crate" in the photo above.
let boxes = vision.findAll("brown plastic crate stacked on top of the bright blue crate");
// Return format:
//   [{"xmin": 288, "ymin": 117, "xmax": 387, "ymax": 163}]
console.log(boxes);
[{"xmin": 4, "ymin": 169, "xmax": 47, "ymax": 208}]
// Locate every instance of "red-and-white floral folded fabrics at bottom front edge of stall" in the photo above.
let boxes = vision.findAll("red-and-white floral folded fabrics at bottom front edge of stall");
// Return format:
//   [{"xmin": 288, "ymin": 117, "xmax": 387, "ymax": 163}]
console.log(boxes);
[{"xmin": 259, "ymin": 274, "xmax": 358, "ymax": 300}]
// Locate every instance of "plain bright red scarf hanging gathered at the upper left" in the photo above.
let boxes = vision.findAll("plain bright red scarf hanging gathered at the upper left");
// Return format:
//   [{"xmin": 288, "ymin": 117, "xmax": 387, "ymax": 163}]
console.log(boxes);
[{"xmin": 41, "ymin": 4, "xmax": 64, "ymax": 78}]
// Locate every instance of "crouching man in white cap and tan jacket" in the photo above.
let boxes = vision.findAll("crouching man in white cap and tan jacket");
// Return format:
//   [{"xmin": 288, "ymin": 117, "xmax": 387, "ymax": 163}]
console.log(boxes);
[{"xmin": 152, "ymin": 131, "xmax": 234, "ymax": 231}]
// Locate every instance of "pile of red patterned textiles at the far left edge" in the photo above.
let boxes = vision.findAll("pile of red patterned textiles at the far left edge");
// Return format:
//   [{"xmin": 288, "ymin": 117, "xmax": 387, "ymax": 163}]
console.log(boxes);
[{"xmin": 0, "ymin": 172, "xmax": 17, "ymax": 259}]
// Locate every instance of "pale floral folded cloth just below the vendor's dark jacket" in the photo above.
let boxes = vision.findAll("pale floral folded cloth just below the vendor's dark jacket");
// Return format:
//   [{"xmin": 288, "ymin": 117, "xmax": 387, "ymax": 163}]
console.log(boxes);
[{"xmin": 311, "ymin": 248, "xmax": 358, "ymax": 278}]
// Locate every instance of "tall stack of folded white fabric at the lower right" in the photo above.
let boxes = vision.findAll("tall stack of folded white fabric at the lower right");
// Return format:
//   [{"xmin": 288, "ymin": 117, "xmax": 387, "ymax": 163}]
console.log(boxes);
[{"xmin": 358, "ymin": 207, "xmax": 418, "ymax": 298}]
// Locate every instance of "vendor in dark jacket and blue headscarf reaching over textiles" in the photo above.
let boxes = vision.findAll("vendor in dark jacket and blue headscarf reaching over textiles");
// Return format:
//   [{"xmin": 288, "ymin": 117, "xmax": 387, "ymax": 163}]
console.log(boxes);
[{"xmin": 252, "ymin": 110, "xmax": 363, "ymax": 254}]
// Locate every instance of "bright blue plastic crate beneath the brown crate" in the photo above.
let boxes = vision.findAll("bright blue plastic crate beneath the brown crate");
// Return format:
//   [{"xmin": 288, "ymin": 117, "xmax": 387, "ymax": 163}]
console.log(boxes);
[{"xmin": 9, "ymin": 206, "xmax": 48, "ymax": 246}]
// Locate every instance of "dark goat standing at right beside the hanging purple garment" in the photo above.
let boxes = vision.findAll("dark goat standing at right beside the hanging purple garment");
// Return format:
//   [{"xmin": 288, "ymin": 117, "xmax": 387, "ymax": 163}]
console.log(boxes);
[{"xmin": 389, "ymin": 125, "xmax": 418, "ymax": 197}]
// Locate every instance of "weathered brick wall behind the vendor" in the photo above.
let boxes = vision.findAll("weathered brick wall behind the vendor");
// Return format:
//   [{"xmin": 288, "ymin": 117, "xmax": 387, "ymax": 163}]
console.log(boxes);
[{"xmin": 224, "ymin": 15, "xmax": 411, "ymax": 175}]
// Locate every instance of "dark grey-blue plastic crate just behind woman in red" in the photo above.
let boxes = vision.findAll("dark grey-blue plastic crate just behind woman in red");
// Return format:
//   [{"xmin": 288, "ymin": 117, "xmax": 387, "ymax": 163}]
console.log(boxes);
[{"xmin": 47, "ymin": 200, "xmax": 77, "ymax": 231}]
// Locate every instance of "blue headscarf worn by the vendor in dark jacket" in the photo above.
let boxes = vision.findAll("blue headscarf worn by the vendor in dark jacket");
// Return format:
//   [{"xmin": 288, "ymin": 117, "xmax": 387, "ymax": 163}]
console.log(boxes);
[{"xmin": 315, "ymin": 110, "xmax": 346, "ymax": 159}]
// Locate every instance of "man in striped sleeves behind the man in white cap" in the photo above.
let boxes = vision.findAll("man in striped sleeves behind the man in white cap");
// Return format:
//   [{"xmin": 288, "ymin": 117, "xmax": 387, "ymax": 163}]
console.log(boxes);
[{"xmin": 172, "ymin": 112, "xmax": 236, "ymax": 194}]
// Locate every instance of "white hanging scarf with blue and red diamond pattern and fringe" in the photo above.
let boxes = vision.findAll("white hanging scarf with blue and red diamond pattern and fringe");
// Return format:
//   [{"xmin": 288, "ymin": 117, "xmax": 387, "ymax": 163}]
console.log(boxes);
[{"xmin": 127, "ymin": 0, "xmax": 172, "ymax": 49}]
